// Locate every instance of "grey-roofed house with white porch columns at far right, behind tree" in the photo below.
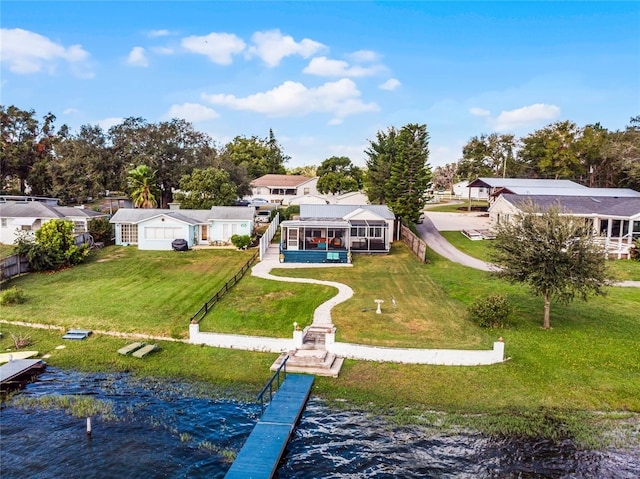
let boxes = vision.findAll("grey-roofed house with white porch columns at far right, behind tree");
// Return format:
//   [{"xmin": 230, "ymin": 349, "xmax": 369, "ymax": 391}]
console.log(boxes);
[{"xmin": 489, "ymin": 193, "xmax": 640, "ymax": 258}]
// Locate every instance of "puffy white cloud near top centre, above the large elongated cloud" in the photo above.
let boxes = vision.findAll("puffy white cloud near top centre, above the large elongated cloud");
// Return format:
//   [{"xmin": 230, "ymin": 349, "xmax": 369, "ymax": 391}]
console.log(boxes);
[{"xmin": 247, "ymin": 30, "xmax": 326, "ymax": 67}]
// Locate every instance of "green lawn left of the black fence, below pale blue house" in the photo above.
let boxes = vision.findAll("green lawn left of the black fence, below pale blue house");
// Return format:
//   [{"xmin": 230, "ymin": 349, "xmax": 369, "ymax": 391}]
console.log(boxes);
[{"xmin": 2, "ymin": 246, "xmax": 253, "ymax": 338}]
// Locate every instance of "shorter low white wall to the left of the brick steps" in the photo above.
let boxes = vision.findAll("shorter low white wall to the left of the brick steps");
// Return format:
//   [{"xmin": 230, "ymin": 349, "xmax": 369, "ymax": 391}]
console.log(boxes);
[{"xmin": 189, "ymin": 324, "xmax": 295, "ymax": 353}]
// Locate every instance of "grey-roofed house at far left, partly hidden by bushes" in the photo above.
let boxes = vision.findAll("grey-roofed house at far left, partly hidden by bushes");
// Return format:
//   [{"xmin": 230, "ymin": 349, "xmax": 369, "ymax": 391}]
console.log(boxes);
[{"xmin": 0, "ymin": 201, "xmax": 108, "ymax": 244}]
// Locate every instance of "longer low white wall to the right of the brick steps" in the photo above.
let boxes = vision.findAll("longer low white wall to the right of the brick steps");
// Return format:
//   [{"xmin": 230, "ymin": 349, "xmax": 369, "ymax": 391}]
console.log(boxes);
[{"xmin": 325, "ymin": 334, "xmax": 504, "ymax": 366}]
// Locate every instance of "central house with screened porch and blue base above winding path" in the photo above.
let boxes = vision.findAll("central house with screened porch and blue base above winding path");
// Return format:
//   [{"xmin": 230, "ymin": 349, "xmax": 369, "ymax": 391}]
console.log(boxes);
[{"xmin": 280, "ymin": 204, "xmax": 395, "ymax": 263}]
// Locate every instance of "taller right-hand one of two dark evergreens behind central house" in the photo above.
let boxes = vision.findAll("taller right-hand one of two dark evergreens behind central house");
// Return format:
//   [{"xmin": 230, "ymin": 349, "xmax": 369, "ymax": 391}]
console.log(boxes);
[{"xmin": 386, "ymin": 123, "xmax": 431, "ymax": 223}]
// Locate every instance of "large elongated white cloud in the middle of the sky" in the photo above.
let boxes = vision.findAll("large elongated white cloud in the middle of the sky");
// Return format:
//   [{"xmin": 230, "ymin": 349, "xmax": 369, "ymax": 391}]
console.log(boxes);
[{"xmin": 202, "ymin": 78, "xmax": 379, "ymax": 122}]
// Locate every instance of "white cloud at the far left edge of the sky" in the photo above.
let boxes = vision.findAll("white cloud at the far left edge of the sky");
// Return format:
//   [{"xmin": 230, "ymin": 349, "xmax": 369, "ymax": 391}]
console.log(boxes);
[{"xmin": 0, "ymin": 28, "xmax": 93, "ymax": 78}]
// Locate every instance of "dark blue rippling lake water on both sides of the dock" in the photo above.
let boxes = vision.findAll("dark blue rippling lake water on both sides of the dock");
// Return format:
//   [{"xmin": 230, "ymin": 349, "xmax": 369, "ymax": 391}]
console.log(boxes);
[{"xmin": 0, "ymin": 368, "xmax": 640, "ymax": 479}]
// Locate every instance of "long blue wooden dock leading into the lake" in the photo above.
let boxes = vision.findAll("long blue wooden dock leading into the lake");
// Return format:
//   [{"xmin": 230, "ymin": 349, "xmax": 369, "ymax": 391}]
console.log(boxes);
[{"xmin": 224, "ymin": 374, "xmax": 314, "ymax": 479}]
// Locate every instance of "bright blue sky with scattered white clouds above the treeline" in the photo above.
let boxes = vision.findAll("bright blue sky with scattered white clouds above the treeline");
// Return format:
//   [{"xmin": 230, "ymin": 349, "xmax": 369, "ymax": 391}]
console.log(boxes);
[{"xmin": 0, "ymin": 0, "xmax": 640, "ymax": 167}]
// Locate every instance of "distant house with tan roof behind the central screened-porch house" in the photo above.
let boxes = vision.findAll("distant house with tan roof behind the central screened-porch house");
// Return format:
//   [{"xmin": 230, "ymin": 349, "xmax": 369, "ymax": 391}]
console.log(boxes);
[{"xmin": 246, "ymin": 174, "xmax": 318, "ymax": 205}]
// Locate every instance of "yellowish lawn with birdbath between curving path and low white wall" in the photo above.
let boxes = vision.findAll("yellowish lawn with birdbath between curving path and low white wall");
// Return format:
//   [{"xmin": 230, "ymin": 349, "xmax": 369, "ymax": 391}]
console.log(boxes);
[{"xmin": 272, "ymin": 244, "xmax": 497, "ymax": 349}]
